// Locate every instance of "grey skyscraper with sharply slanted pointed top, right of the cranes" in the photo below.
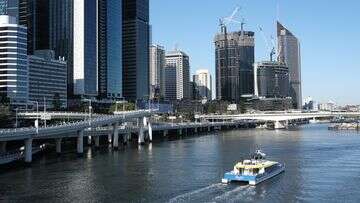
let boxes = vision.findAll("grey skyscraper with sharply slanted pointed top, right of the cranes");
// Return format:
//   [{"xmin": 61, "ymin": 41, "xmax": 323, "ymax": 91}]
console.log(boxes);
[{"xmin": 277, "ymin": 22, "xmax": 302, "ymax": 109}]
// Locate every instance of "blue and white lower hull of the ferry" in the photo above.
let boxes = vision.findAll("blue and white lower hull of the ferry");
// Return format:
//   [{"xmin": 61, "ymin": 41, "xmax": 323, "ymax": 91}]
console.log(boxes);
[{"xmin": 222, "ymin": 165, "xmax": 285, "ymax": 185}]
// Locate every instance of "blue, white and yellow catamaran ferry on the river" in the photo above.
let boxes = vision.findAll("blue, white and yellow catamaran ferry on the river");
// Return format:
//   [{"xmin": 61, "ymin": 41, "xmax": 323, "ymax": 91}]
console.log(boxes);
[{"xmin": 221, "ymin": 150, "xmax": 285, "ymax": 185}]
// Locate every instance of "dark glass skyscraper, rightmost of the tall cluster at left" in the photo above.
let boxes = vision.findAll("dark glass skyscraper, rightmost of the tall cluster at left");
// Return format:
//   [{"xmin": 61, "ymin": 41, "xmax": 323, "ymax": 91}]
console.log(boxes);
[{"xmin": 123, "ymin": 0, "xmax": 150, "ymax": 100}]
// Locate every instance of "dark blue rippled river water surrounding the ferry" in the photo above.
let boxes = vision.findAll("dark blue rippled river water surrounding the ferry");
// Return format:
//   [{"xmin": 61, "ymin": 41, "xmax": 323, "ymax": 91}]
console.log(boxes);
[{"xmin": 0, "ymin": 125, "xmax": 360, "ymax": 202}]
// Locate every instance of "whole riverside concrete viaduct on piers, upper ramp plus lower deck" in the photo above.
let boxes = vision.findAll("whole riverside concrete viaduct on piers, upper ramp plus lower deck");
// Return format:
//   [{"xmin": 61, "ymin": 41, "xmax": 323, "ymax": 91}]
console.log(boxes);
[{"xmin": 0, "ymin": 110, "xmax": 256, "ymax": 163}]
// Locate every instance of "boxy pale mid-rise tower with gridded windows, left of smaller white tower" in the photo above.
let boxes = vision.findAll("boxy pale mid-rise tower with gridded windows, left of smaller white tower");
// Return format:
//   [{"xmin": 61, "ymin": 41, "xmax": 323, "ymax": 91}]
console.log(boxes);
[{"xmin": 165, "ymin": 51, "xmax": 190, "ymax": 100}]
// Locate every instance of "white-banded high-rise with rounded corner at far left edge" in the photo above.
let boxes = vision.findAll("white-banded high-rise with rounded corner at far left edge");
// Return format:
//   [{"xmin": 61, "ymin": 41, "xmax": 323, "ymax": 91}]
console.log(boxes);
[{"xmin": 0, "ymin": 15, "xmax": 29, "ymax": 106}]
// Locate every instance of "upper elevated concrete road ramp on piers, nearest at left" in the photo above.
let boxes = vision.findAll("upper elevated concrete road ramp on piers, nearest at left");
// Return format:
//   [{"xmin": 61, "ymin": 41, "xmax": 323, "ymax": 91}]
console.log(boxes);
[{"xmin": 0, "ymin": 110, "xmax": 155, "ymax": 163}]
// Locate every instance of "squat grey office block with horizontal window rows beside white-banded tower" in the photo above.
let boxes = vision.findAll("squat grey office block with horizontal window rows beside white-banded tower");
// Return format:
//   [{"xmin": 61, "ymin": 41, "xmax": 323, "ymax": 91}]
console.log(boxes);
[{"xmin": 29, "ymin": 50, "xmax": 67, "ymax": 109}]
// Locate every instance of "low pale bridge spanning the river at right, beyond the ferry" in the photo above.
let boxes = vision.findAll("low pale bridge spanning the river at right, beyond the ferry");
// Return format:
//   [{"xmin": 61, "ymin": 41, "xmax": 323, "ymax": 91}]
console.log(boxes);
[{"xmin": 198, "ymin": 112, "xmax": 360, "ymax": 129}]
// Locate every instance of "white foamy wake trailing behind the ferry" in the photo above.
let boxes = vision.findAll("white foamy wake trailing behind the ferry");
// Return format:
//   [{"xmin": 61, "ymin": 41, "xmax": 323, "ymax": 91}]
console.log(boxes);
[{"xmin": 169, "ymin": 183, "xmax": 255, "ymax": 203}]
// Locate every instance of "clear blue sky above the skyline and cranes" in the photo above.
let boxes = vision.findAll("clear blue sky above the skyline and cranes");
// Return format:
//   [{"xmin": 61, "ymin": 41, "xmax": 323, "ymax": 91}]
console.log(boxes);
[{"xmin": 150, "ymin": 0, "xmax": 360, "ymax": 104}]
